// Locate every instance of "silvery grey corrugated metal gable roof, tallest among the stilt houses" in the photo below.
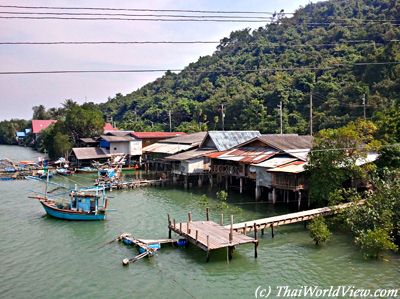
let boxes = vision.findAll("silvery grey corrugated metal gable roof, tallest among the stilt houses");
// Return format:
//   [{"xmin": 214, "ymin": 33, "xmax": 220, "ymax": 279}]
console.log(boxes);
[{"xmin": 200, "ymin": 131, "xmax": 261, "ymax": 152}]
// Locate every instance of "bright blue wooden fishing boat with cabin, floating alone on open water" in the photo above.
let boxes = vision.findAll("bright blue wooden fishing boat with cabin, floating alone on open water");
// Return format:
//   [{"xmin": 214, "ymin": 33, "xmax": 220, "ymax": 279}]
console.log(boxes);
[{"xmin": 28, "ymin": 177, "xmax": 108, "ymax": 221}]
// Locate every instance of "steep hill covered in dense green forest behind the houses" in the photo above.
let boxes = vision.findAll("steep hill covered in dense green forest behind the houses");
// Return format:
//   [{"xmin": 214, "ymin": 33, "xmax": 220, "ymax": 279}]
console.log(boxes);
[{"xmin": 100, "ymin": 0, "xmax": 400, "ymax": 133}]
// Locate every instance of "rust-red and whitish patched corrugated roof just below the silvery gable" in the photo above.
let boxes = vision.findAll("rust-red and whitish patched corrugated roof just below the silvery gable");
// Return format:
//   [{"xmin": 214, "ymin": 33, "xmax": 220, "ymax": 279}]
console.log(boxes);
[{"xmin": 207, "ymin": 147, "xmax": 278, "ymax": 164}]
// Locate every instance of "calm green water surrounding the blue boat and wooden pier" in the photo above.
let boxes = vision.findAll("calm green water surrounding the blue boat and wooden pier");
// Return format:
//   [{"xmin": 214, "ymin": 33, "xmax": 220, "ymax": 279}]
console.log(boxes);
[{"xmin": 0, "ymin": 146, "xmax": 400, "ymax": 299}]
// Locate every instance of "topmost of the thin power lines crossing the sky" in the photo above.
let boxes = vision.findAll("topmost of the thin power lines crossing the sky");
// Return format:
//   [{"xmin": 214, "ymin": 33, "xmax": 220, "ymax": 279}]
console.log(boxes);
[{"xmin": 0, "ymin": 5, "xmax": 294, "ymax": 15}]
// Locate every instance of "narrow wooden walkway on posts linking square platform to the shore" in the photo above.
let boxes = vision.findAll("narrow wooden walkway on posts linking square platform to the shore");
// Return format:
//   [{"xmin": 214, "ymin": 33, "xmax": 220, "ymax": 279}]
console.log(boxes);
[{"xmin": 225, "ymin": 201, "xmax": 364, "ymax": 234}]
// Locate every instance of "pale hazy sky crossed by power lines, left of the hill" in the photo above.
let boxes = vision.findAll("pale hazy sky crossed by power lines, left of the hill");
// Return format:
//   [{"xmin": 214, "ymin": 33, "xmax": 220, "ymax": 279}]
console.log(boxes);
[{"xmin": 0, "ymin": 0, "xmax": 317, "ymax": 120}]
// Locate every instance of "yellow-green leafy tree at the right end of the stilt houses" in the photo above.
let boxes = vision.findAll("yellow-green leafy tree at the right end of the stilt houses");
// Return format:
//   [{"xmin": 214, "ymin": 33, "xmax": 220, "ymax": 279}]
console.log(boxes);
[{"xmin": 307, "ymin": 119, "xmax": 380, "ymax": 205}]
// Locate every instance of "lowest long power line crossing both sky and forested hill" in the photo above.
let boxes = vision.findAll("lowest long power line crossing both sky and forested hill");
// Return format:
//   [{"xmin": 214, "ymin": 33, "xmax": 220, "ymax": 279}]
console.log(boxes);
[{"xmin": 0, "ymin": 61, "xmax": 400, "ymax": 75}]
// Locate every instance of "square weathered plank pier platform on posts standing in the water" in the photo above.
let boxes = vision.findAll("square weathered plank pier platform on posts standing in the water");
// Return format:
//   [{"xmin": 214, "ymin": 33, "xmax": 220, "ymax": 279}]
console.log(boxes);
[{"xmin": 168, "ymin": 209, "xmax": 258, "ymax": 262}]
